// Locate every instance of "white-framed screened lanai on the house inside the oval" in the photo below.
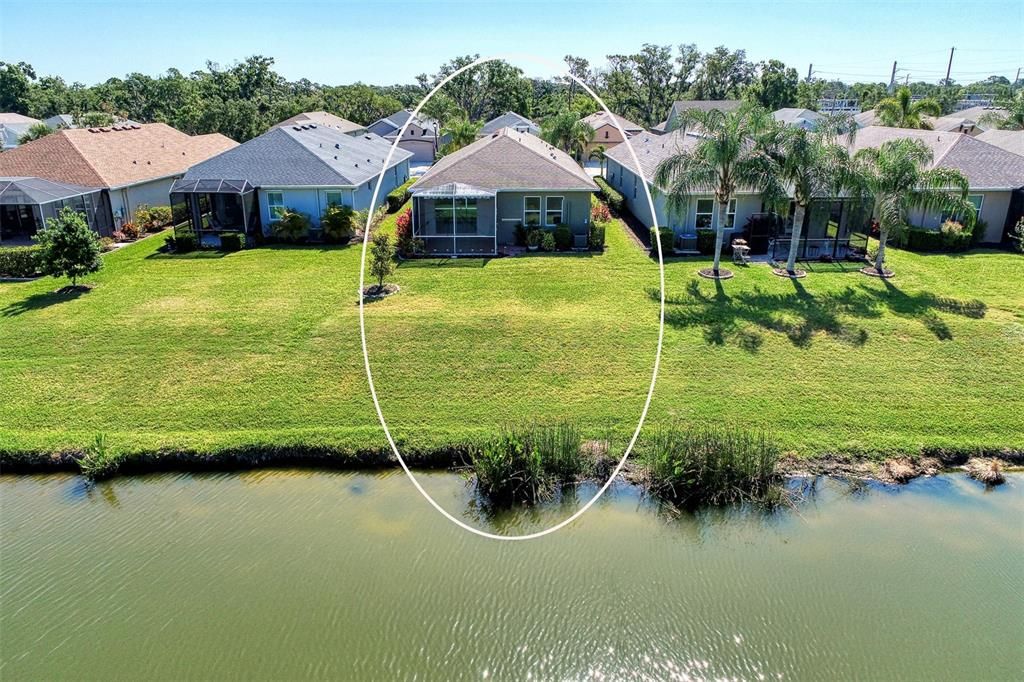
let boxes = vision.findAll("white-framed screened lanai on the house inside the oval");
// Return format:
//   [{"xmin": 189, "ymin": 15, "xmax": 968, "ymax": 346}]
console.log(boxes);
[{"xmin": 413, "ymin": 182, "xmax": 498, "ymax": 256}]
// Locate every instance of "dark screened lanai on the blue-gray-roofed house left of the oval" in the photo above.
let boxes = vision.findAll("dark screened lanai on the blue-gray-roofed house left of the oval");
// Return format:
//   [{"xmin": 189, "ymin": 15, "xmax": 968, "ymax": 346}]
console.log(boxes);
[{"xmin": 171, "ymin": 179, "xmax": 260, "ymax": 242}]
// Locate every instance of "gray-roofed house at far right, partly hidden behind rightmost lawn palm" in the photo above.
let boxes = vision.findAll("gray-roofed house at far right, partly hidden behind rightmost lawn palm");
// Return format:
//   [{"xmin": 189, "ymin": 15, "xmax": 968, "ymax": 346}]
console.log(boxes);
[{"xmin": 850, "ymin": 126, "xmax": 1024, "ymax": 244}]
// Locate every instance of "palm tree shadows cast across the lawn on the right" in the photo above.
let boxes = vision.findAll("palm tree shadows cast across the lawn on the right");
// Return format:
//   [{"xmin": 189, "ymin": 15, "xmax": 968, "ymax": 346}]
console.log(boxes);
[{"xmin": 647, "ymin": 268, "xmax": 987, "ymax": 353}]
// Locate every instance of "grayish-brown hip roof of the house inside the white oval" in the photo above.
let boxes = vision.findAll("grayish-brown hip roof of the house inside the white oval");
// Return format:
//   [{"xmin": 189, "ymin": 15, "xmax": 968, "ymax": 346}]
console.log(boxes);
[{"xmin": 413, "ymin": 128, "xmax": 597, "ymax": 194}]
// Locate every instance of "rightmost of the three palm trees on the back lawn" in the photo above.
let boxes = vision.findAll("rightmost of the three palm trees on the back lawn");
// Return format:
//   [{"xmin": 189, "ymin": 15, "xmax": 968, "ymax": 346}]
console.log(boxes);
[{"xmin": 849, "ymin": 138, "xmax": 975, "ymax": 274}]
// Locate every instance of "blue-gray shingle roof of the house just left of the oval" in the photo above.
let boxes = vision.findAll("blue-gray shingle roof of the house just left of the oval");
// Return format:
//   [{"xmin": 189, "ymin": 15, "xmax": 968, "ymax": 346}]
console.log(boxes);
[{"xmin": 180, "ymin": 125, "xmax": 413, "ymax": 187}]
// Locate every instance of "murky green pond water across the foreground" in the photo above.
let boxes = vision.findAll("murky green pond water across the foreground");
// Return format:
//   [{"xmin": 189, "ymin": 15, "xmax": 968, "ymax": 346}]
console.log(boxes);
[{"xmin": 0, "ymin": 470, "xmax": 1024, "ymax": 681}]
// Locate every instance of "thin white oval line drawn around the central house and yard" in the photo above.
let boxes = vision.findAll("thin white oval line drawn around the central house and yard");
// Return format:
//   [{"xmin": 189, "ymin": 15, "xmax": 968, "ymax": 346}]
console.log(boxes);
[{"xmin": 359, "ymin": 52, "xmax": 665, "ymax": 542}]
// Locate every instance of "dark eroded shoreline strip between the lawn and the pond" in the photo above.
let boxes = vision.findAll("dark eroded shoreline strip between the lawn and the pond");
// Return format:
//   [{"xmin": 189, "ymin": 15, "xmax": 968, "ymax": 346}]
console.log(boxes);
[{"xmin": 0, "ymin": 444, "xmax": 1024, "ymax": 484}]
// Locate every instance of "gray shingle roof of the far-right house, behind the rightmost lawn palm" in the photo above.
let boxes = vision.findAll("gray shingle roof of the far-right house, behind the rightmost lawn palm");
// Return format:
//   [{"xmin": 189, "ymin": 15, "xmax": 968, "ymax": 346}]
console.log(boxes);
[{"xmin": 850, "ymin": 126, "xmax": 1024, "ymax": 190}]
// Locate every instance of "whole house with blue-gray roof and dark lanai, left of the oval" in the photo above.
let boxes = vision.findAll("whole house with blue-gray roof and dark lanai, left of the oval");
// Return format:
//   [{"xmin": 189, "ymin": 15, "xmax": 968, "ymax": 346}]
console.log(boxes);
[{"xmin": 171, "ymin": 124, "xmax": 413, "ymax": 238}]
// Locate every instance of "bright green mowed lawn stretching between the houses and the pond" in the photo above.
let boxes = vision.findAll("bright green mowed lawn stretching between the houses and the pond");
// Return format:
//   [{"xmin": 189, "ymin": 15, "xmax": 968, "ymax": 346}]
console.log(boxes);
[{"xmin": 0, "ymin": 209, "xmax": 1024, "ymax": 456}]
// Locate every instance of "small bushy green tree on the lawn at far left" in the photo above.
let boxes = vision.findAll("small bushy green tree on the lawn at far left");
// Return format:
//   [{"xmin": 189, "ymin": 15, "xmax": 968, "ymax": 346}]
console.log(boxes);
[{"xmin": 36, "ymin": 206, "xmax": 103, "ymax": 287}]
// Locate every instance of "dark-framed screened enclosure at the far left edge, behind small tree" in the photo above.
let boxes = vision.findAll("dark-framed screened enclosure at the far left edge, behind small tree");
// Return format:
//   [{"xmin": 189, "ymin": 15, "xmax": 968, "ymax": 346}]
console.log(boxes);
[{"xmin": 0, "ymin": 177, "xmax": 114, "ymax": 244}]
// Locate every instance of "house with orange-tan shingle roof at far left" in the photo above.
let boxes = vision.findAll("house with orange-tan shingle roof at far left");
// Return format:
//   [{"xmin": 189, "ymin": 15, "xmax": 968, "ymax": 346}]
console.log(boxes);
[{"xmin": 0, "ymin": 123, "xmax": 238, "ymax": 228}]
